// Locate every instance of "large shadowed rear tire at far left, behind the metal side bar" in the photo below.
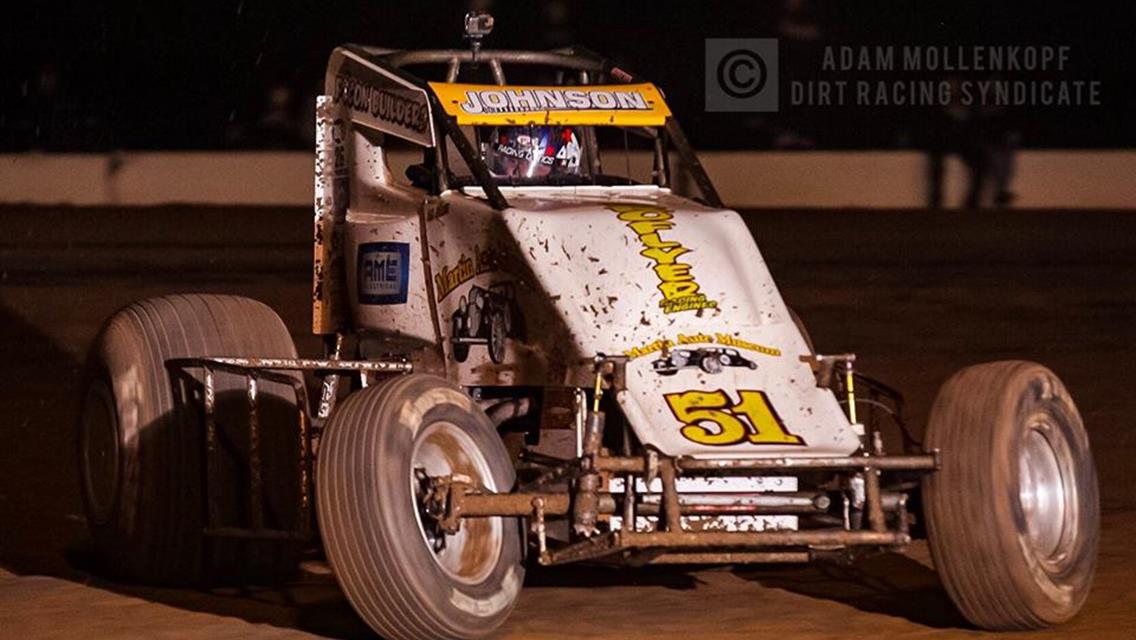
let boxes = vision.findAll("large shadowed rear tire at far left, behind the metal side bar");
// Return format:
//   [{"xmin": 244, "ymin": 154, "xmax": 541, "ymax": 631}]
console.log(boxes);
[{"xmin": 78, "ymin": 296, "xmax": 299, "ymax": 584}]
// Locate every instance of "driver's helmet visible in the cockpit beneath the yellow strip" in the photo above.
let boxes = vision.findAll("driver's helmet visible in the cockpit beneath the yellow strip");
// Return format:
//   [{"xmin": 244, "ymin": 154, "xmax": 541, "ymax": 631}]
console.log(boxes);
[{"xmin": 486, "ymin": 126, "xmax": 579, "ymax": 177}]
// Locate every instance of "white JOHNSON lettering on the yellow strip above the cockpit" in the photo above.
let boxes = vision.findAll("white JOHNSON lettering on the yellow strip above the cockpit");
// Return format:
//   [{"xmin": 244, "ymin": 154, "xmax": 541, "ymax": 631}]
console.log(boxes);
[{"xmin": 458, "ymin": 89, "xmax": 651, "ymax": 115}]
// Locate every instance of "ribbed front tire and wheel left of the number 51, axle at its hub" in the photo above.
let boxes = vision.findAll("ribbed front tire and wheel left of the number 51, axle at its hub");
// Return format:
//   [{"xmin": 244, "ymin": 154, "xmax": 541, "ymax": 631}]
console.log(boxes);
[{"xmin": 316, "ymin": 374, "xmax": 525, "ymax": 640}]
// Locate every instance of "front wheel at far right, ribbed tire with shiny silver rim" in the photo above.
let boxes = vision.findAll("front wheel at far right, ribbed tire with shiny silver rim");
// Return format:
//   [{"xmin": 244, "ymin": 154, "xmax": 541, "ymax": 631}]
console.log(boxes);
[{"xmin": 924, "ymin": 361, "xmax": 1100, "ymax": 630}]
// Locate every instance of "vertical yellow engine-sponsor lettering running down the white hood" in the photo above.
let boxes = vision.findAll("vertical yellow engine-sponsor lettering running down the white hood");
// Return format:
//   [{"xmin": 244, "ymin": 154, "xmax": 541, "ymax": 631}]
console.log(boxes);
[{"xmin": 608, "ymin": 205, "xmax": 718, "ymax": 314}]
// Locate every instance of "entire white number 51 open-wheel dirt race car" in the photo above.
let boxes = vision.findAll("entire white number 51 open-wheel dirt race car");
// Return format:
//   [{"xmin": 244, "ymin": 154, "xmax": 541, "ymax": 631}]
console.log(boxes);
[{"xmin": 80, "ymin": 16, "xmax": 1099, "ymax": 638}]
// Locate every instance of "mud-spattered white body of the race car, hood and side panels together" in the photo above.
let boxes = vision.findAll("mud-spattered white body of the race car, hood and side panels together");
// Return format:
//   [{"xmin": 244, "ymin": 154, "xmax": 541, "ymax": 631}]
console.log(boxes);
[{"xmin": 345, "ymin": 175, "xmax": 860, "ymax": 458}]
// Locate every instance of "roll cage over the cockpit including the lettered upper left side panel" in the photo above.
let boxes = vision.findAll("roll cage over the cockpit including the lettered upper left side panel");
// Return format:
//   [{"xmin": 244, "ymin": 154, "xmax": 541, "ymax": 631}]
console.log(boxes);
[{"xmin": 325, "ymin": 44, "xmax": 721, "ymax": 209}]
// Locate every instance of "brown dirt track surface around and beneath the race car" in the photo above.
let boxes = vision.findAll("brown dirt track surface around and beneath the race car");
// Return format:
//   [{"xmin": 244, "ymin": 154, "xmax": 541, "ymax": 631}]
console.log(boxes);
[{"xmin": 0, "ymin": 207, "xmax": 1136, "ymax": 639}]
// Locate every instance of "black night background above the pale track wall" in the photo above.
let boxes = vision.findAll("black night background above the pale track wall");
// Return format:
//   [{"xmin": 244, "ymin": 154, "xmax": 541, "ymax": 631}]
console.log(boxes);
[{"xmin": 0, "ymin": 0, "xmax": 1136, "ymax": 151}]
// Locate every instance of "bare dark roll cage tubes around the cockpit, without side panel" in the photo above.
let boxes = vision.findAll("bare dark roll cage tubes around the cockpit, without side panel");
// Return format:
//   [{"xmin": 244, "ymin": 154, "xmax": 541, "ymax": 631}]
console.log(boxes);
[{"xmin": 342, "ymin": 44, "xmax": 722, "ymax": 210}]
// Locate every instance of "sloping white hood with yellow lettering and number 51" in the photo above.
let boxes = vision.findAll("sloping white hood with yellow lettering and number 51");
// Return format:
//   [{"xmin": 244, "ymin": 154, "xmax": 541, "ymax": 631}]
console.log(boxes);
[{"xmin": 504, "ymin": 189, "xmax": 859, "ymax": 457}]
